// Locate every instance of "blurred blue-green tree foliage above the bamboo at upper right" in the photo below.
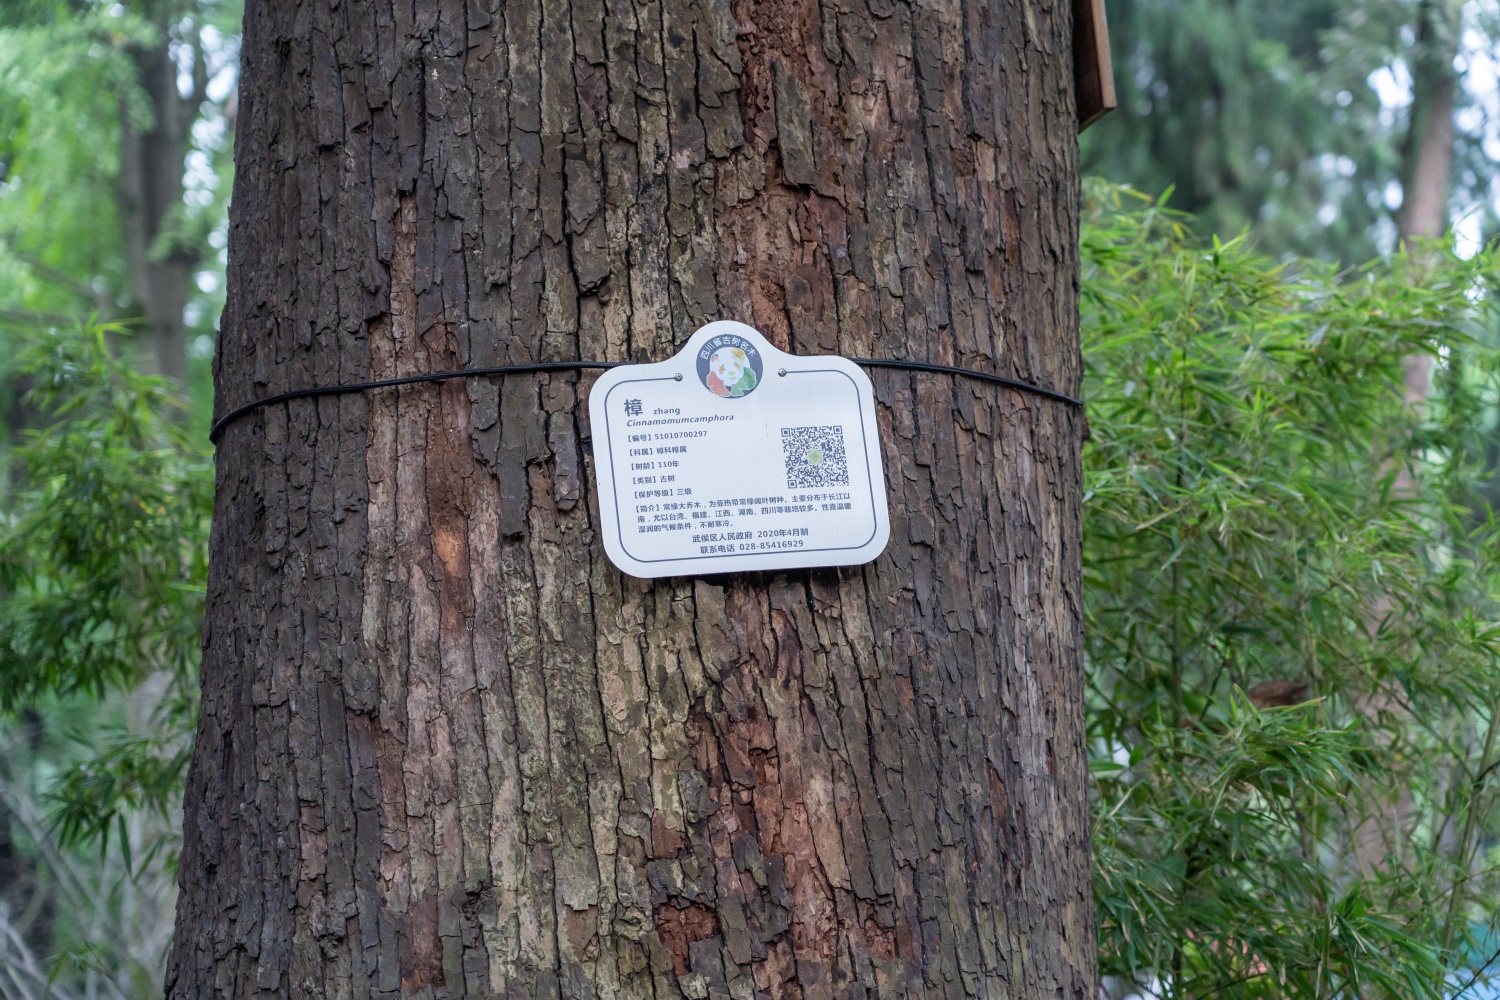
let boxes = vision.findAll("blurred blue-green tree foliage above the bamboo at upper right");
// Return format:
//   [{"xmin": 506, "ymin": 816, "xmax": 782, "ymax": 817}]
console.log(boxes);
[{"xmin": 1082, "ymin": 0, "xmax": 1500, "ymax": 264}]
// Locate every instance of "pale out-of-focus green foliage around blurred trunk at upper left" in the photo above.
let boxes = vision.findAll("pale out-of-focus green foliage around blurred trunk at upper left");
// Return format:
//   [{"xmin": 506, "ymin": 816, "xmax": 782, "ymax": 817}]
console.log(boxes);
[{"xmin": 0, "ymin": 0, "xmax": 239, "ymax": 407}]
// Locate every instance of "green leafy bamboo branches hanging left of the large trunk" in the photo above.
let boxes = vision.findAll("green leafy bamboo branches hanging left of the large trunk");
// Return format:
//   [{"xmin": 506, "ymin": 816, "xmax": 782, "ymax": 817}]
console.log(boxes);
[{"xmin": 0, "ymin": 325, "xmax": 213, "ymax": 865}]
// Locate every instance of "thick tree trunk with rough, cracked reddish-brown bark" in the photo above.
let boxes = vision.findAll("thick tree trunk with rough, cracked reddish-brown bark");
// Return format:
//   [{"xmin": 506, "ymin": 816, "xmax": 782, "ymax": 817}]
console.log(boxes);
[{"xmin": 167, "ymin": 0, "xmax": 1094, "ymax": 1000}]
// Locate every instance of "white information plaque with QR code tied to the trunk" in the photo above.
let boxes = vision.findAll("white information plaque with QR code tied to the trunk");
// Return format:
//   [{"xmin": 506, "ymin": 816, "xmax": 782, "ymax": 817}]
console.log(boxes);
[{"xmin": 588, "ymin": 321, "xmax": 891, "ymax": 577}]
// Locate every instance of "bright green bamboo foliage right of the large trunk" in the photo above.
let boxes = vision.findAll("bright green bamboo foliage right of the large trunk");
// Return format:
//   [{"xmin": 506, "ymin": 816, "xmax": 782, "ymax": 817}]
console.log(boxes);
[{"xmin": 1083, "ymin": 186, "xmax": 1500, "ymax": 997}]
